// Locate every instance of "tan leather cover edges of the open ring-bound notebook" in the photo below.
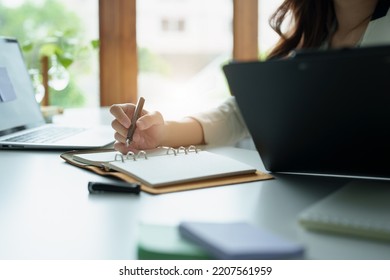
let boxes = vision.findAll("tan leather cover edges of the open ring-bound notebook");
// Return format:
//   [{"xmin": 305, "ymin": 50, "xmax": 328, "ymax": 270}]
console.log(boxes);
[{"xmin": 61, "ymin": 149, "xmax": 273, "ymax": 194}]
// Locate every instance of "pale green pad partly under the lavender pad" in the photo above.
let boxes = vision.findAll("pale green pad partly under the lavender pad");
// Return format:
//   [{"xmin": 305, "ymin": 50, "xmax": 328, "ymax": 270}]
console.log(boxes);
[{"xmin": 137, "ymin": 224, "xmax": 211, "ymax": 260}]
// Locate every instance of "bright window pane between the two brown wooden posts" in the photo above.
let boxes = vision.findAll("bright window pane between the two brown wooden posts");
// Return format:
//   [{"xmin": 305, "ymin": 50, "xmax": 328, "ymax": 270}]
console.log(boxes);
[{"xmin": 137, "ymin": 0, "xmax": 233, "ymax": 118}]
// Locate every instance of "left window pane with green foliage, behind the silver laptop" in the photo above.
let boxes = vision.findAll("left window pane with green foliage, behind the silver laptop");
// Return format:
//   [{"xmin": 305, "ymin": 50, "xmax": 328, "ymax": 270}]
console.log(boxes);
[{"xmin": 0, "ymin": 0, "xmax": 99, "ymax": 107}]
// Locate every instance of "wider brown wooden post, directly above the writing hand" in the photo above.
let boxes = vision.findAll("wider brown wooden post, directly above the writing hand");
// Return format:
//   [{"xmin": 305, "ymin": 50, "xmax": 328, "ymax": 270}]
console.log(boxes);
[{"xmin": 99, "ymin": 0, "xmax": 138, "ymax": 106}]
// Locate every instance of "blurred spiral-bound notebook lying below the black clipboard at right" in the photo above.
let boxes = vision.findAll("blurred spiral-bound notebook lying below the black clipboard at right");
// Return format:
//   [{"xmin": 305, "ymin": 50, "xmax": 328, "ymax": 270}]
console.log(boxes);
[{"xmin": 299, "ymin": 180, "xmax": 390, "ymax": 241}]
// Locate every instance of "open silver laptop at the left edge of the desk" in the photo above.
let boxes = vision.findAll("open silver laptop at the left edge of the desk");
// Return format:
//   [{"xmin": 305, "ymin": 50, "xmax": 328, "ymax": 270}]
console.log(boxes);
[{"xmin": 0, "ymin": 37, "xmax": 114, "ymax": 149}]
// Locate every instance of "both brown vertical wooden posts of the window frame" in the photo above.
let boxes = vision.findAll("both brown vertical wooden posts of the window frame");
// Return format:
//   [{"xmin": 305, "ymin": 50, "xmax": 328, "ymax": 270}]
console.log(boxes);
[{"xmin": 99, "ymin": 0, "xmax": 258, "ymax": 106}]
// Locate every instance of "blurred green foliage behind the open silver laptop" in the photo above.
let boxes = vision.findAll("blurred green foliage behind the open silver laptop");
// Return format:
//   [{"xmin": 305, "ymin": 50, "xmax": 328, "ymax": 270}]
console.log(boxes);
[{"xmin": 0, "ymin": 0, "xmax": 98, "ymax": 107}]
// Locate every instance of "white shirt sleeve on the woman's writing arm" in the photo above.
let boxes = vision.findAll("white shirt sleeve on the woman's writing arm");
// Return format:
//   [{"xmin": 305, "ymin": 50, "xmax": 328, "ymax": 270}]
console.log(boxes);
[{"xmin": 191, "ymin": 96, "xmax": 249, "ymax": 145}]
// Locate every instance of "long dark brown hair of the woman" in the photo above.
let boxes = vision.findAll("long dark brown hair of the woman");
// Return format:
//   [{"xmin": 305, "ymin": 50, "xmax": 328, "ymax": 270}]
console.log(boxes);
[{"xmin": 268, "ymin": 0, "xmax": 336, "ymax": 58}]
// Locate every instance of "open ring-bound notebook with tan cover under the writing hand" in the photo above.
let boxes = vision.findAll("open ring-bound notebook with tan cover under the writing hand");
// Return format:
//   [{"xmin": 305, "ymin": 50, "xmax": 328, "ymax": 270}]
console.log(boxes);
[{"xmin": 61, "ymin": 146, "xmax": 272, "ymax": 193}]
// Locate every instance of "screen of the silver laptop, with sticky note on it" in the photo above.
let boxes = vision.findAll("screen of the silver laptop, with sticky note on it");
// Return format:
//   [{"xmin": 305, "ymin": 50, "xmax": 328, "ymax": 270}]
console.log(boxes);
[{"xmin": 0, "ymin": 38, "xmax": 44, "ymax": 136}]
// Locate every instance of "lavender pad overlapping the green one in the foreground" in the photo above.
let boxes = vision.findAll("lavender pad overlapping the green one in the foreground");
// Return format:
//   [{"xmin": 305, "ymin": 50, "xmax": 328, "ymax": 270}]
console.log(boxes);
[{"xmin": 179, "ymin": 222, "xmax": 303, "ymax": 260}]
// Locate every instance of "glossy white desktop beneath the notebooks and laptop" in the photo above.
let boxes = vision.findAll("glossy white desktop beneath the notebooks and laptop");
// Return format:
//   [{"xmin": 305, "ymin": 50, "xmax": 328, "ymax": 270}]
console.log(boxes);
[{"xmin": 0, "ymin": 106, "xmax": 390, "ymax": 259}]
